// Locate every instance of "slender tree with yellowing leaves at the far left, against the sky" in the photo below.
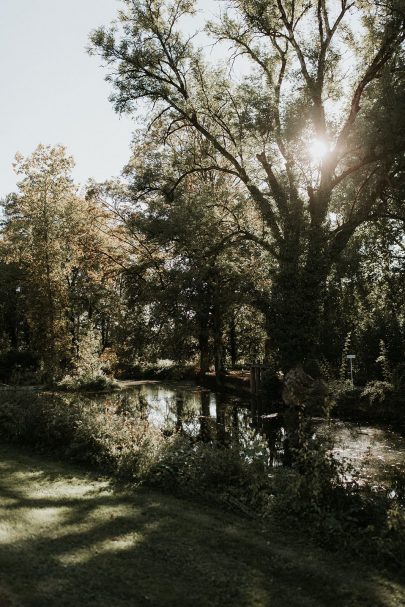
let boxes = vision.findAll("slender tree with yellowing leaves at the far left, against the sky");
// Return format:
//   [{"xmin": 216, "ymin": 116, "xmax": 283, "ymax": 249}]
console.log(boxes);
[{"xmin": 0, "ymin": 145, "xmax": 80, "ymax": 378}]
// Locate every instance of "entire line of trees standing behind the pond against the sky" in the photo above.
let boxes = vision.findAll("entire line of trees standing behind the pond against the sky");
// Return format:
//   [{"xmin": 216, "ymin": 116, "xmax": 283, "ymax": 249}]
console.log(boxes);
[{"xmin": 0, "ymin": 0, "xmax": 405, "ymax": 382}]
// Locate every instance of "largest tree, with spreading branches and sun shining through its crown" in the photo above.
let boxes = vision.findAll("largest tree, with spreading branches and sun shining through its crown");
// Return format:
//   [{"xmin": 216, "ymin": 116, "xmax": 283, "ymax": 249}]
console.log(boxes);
[{"xmin": 92, "ymin": 0, "xmax": 405, "ymax": 369}]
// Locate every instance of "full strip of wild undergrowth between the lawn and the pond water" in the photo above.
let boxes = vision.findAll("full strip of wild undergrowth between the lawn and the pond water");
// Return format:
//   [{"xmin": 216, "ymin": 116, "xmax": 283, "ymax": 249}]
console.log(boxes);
[{"xmin": 0, "ymin": 393, "xmax": 405, "ymax": 563}]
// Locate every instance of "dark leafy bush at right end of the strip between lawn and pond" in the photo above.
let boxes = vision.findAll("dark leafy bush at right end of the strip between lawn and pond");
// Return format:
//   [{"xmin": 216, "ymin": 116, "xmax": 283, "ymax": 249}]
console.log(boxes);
[{"xmin": 273, "ymin": 426, "xmax": 405, "ymax": 563}]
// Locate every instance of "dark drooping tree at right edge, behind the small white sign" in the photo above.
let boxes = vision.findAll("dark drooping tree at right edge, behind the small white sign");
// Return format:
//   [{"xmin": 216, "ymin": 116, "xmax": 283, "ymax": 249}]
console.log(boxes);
[{"xmin": 322, "ymin": 219, "xmax": 405, "ymax": 383}]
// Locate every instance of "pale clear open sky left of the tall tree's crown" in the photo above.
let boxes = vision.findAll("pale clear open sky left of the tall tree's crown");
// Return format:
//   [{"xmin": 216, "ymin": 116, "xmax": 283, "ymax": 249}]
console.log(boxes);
[{"xmin": 0, "ymin": 0, "xmax": 134, "ymax": 197}]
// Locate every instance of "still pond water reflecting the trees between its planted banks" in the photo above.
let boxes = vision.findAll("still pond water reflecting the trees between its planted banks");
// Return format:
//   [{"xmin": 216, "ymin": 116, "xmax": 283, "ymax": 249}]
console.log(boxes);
[{"xmin": 98, "ymin": 382, "xmax": 405, "ymax": 482}]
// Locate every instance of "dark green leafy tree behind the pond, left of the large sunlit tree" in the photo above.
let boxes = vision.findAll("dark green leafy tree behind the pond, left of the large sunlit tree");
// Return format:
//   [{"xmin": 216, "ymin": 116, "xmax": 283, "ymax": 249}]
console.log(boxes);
[{"xmin": 99, "ymin": 133, "xmax": 268, "ymax": 374}]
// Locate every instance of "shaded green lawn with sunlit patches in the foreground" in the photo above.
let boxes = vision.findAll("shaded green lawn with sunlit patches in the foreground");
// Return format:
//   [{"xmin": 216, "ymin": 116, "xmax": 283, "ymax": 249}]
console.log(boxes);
[{"xmin": 0, "ymin": 445, "xmax": 405, "ymax": 607}]
